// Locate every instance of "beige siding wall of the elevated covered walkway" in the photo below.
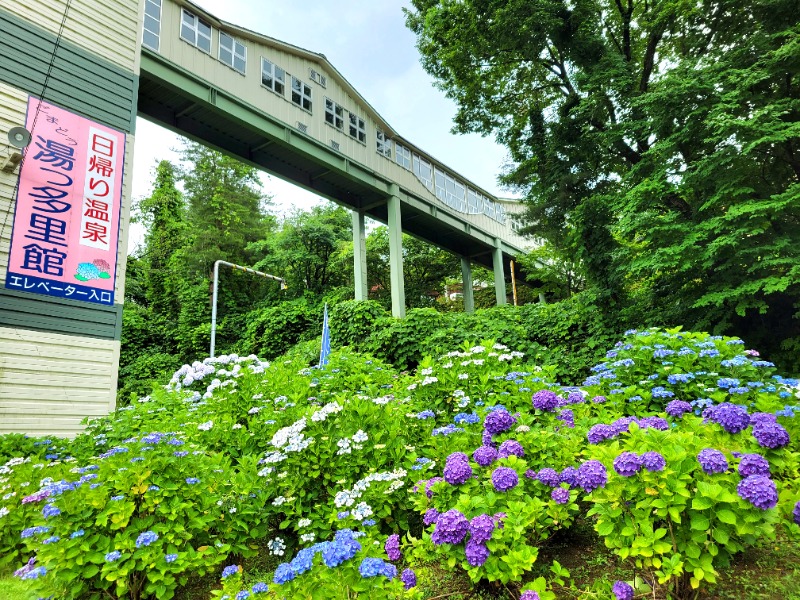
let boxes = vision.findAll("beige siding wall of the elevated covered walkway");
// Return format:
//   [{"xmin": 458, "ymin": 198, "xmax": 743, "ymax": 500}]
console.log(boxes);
[{"xmin": 159, "ymin": 0, "xmax": 527, "ymax": 245}]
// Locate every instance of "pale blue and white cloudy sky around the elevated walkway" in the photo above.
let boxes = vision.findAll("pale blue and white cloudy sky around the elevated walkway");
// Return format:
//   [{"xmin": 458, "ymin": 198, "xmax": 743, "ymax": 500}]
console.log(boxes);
[{"xmin": 128, "ymin": 0, "xmax": 510, "ymax": 252}]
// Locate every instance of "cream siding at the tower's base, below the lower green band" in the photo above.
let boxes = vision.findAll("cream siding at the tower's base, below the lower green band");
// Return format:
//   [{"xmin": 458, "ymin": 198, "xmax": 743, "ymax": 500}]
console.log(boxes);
[{"xmin": 0, "ymin": 327, "xmax": 119, "ymax": 436}]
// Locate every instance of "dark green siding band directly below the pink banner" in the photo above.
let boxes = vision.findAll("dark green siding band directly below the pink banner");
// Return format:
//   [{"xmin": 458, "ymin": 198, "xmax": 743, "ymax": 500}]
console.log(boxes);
[{"xmin": 0, "ymin": 288, "xmax": 122, "ymax": 340}]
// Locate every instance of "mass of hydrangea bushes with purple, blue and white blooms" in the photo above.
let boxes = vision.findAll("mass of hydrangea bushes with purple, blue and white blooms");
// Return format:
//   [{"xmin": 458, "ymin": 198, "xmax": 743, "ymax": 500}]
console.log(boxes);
[{"xmin": 0, "ymin": 330, "xmax": 800, "ymax": 600}]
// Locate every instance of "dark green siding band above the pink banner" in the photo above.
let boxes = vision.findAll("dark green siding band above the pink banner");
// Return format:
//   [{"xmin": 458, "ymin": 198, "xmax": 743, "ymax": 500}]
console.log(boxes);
[{"xmin": 0, "ymin": 9, "xmax": 139, "ymax": 133}]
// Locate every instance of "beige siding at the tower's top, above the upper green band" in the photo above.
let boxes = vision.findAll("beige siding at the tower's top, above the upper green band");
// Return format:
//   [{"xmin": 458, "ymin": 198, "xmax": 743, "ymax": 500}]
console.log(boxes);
[{"xmin": 0, "ymin": 0, "xmax": 141, "ymax": 73}]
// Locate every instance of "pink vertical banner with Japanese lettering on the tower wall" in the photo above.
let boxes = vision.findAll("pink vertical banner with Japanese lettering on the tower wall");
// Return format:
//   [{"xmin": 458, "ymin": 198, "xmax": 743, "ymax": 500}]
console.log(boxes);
[{"xmin": 5, "ymin": 96, "xmax": 125, "ymax": 305}]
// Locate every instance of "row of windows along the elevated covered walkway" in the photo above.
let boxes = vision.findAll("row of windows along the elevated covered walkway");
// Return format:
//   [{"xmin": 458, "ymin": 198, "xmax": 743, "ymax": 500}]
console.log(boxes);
[{"xmin": 142, "ymin": 0, "xmax": 506, "ymax": 223}]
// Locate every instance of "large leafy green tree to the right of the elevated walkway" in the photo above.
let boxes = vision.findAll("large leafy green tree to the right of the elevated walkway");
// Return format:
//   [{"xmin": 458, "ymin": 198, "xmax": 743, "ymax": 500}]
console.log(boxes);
[{"xmin": 407, "ymin": 0, "xmax": 800, "ymax": 366}]
